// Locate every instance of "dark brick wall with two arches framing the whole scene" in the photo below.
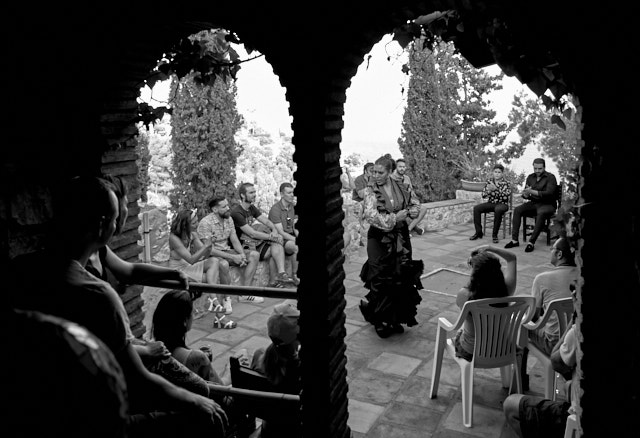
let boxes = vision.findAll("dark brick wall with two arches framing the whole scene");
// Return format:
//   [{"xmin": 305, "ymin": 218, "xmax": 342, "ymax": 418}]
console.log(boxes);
[{"xmin": 0, "ymin": 0, "xmax": 640, "ymax": 436}]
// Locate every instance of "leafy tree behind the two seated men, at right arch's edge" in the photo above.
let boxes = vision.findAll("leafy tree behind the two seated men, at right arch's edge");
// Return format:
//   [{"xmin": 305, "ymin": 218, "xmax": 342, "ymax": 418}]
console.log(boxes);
[{"xmin": 509, "ymin": 93, "xmax": 580, "ymax": 199}]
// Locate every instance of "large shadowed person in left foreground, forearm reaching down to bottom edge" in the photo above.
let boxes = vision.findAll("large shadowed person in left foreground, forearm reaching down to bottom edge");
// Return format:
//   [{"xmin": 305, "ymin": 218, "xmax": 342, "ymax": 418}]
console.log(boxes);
[{"xmin": 10, "ymin": 177, "xmax": 228, "ymax": 438}]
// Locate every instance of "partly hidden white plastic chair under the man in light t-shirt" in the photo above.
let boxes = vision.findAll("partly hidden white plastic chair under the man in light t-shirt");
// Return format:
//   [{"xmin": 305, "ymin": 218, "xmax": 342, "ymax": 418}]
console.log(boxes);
[{"xmin": 519, "ymin": 297, "xmax": 573, "ymax": 400}]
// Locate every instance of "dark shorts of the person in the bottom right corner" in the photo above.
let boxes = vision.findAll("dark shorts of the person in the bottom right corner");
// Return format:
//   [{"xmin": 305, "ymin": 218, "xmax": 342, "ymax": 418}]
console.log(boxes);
[{"xmin": 518, "ymin": 395, "xmax": 571, "ymax": 438}]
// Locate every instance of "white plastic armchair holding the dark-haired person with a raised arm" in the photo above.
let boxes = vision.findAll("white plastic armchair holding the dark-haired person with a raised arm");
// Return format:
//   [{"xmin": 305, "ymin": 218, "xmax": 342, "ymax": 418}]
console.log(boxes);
[{"xmin": 430, "ymin": 296, "xmax": 535, "ymax": 427}]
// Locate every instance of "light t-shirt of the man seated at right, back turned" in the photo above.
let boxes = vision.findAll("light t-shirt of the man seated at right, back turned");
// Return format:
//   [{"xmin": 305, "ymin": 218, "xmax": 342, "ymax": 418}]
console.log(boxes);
[{"xmin": 531, "ymin": 266, "xmax": 578, "ymax": 341}]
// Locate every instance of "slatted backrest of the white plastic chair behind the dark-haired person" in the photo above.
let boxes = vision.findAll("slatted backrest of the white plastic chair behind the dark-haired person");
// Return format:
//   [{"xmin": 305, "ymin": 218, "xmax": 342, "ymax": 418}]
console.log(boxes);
[{"xmin": 462, "ymin": 296, "xmax": 535, "ymax": 368}]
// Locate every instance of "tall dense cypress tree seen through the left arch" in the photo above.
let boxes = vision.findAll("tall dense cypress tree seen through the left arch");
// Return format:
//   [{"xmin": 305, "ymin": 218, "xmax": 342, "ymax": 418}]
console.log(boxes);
[{"xmin": 170, "ymin": 67, "xmax": 242, "ymax": 211}]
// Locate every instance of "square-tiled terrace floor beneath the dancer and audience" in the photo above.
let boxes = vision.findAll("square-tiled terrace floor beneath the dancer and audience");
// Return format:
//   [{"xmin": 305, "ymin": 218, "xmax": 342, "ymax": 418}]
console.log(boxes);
[{"xmin": 178, "ymin": 224, "xmax": 563, "ymax": 438}]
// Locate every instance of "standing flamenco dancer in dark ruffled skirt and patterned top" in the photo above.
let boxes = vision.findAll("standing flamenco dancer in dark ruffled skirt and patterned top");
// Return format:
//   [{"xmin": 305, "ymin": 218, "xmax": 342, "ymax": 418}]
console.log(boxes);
[{"xmin": 360, "ymin": 156, "xmax": 424, "ymax": 338}]
